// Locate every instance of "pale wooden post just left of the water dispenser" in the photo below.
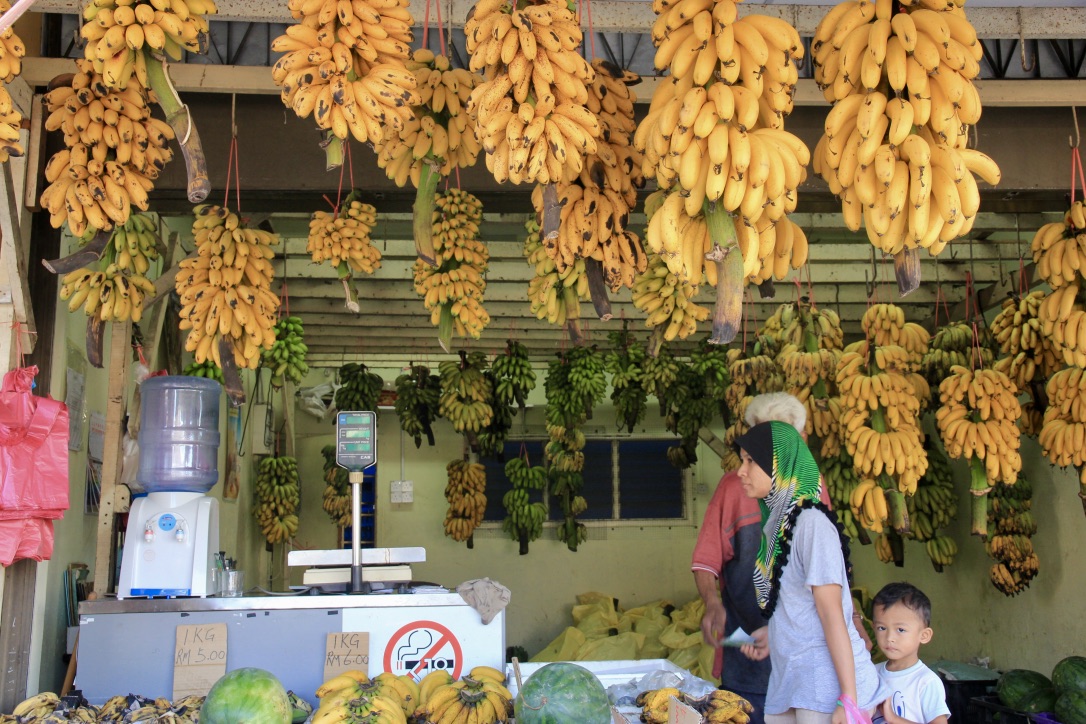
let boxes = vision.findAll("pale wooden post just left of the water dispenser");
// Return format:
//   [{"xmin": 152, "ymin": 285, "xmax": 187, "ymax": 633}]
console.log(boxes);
[{"xmin": 94, "ymin": 321, "xmax": 132, "ymax": 596}]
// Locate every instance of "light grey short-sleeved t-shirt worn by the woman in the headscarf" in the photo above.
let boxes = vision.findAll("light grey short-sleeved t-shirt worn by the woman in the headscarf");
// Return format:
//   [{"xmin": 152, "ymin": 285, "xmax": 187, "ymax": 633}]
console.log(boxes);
[{"xmin": 766, "ymin": 508, "xmax": 888, "ymax": 714}]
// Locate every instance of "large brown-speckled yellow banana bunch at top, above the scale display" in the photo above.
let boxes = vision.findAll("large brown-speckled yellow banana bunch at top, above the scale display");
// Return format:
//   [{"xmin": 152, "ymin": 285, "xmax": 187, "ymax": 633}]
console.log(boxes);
[{"xmin": 272, "ymin": 0, "xmax": 419, "ymax": 148}]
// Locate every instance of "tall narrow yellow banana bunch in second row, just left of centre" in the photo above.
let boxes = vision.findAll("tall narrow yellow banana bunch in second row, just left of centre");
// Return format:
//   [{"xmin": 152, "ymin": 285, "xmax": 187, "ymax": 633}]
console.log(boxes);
[{"xmin": 415, "ymin": 189, "xmax": 490, "ymax": 352}]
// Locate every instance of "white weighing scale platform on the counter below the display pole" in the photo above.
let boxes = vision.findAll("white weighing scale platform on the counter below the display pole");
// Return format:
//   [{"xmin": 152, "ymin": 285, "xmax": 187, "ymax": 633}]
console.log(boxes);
[{"xmin": 287, "ymin": 547, "xmax": 426, "ymax": 593}]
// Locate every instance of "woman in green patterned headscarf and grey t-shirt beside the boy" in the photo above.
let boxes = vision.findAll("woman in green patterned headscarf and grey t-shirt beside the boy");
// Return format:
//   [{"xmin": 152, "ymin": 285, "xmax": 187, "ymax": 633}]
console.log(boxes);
[{"xmin": 735, "ymin": 422, "xmax": 887, "ymax": 724}]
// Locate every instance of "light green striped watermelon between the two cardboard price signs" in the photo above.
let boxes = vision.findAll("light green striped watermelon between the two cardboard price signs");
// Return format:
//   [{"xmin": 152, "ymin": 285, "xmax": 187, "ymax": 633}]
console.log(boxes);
[{"xmin": 200, "ymin": 668, "xmax": 293, "ymax": 724}]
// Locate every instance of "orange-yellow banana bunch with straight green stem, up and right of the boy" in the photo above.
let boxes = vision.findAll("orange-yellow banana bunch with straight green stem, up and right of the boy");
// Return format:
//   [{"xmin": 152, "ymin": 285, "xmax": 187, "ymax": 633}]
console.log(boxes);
[{"xmin": 935, "ymin": 366, "xmax": 1022, "ymax": 536}]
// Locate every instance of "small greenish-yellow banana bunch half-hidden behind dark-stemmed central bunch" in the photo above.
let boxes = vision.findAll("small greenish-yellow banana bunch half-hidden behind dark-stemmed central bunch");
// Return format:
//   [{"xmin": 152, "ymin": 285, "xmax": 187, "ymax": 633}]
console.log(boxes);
[{"xmin": 525, "ymin": 203, "xmax": 589, "ymax": 336}]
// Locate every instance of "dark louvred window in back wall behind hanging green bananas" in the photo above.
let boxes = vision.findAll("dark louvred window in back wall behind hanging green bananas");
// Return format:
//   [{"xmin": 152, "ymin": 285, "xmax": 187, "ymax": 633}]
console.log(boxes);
[{"xmin": 482, "ymin": 437, "xmax": 686, "ymax": 523}]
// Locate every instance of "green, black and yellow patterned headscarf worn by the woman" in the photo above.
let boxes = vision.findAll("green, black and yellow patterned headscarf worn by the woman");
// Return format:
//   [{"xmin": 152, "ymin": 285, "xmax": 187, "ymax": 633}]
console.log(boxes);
[{"xmin": 735, "ymin": 421, "xmax": 829, "ymax": 618}]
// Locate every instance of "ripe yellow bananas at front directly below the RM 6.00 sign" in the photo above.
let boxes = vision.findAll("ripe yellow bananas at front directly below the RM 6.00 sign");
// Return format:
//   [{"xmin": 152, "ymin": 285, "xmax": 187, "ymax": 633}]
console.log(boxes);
[{"xmin": 311, "ymin": 671, "xmax": 408, "ymax": 724}]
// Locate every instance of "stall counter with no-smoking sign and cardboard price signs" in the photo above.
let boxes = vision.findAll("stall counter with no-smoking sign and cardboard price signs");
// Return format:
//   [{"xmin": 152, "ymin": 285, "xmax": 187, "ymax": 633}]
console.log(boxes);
[{"xmin": 75, "ymin": 593, "xmax": 505, "ymax": 706}]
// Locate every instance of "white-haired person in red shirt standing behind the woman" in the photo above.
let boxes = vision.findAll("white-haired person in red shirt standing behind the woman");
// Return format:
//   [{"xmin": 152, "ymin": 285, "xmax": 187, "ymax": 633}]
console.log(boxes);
[{"xmin": 691, "ymin": 392, "xmax": 828, "ymax": 724}]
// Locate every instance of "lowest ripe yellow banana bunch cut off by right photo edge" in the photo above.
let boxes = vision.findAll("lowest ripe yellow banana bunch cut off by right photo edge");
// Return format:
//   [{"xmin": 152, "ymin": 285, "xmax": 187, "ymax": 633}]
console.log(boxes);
[{"xmin": 1037, "ymin": 367, "xmax": 1086, "ymax": 508}]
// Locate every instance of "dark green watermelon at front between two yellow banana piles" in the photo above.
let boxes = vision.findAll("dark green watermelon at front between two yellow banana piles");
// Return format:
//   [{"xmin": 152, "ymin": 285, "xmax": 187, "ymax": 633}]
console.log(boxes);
[{"xmin": 514, "ymin": 661, "xmax": 611, "ymax": 724}]
